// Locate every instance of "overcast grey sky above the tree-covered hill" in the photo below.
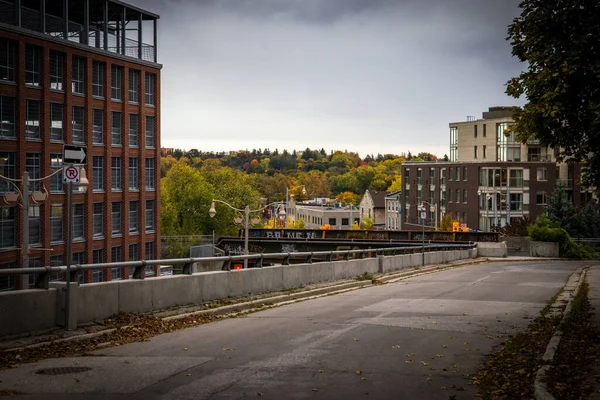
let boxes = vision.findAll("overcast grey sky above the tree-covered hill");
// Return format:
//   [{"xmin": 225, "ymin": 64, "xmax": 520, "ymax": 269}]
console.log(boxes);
[{"xmin": 131, "ymin": 0, "xmax": 524, "ymax": 157}]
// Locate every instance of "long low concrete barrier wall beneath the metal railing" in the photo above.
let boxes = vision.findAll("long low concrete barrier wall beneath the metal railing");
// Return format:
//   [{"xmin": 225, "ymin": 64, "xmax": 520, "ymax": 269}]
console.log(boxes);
[{"xmin": 0, "ymin": 250, "xmax": 476, "ymax": 336}]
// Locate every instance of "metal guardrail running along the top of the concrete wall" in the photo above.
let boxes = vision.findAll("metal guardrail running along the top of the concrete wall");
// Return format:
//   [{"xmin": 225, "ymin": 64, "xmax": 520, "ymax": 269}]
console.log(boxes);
[{"xmin": 0, "ymin": 243, "xmax": 476, "ymax": 289}]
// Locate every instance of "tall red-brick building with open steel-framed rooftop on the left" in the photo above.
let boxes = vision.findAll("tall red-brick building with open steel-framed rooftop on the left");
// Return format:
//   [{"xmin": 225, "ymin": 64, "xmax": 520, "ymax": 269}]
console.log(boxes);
[{"xmin": 0, "ymin": 0, "xmax": 162, "ymax": 290}]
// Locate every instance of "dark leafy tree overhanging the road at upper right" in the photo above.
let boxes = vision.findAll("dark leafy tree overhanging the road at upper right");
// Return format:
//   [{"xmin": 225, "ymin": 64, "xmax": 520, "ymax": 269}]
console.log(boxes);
[{"xmin": 506, "ymin": 0, "xmax": 600, "ymax": 187}]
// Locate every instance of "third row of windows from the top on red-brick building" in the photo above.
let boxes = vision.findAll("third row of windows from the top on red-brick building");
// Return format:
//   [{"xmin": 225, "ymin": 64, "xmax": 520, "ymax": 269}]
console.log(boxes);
[{"xmin": 0, "ymin": 151, "xmax": 156, "ymax": 193}]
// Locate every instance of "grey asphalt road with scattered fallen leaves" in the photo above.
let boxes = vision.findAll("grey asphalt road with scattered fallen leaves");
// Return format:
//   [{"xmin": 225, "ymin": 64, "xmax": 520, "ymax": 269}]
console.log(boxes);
[{"xmin": 0, "ymin": 261, "xmax": 582, "ymax": 400}]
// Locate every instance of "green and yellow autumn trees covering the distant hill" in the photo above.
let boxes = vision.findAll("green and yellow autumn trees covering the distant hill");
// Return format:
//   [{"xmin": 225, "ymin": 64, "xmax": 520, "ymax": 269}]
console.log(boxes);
[{"xmin": 161, "ymin": 148, "xmax": 437, "ymax": 235}]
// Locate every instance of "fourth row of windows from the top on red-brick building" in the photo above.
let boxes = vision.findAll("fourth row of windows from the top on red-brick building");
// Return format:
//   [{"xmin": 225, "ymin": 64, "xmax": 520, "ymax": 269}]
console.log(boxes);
[{"xmin": 0, "ymin": 200, "xmax": 156, "ymax": 248}]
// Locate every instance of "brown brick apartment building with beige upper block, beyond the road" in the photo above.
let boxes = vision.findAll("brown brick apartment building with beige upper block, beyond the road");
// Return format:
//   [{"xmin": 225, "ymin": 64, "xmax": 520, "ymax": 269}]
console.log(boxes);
[{"xmin": 402, "ymin": 107, "xmax": 592, "ymax": 230}]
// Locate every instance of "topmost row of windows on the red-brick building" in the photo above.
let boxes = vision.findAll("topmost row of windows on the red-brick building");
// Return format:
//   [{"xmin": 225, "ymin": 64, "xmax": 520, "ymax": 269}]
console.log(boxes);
[{"xmin": 0, "ymin": 38, "xmax": 156, "ymax": 106}]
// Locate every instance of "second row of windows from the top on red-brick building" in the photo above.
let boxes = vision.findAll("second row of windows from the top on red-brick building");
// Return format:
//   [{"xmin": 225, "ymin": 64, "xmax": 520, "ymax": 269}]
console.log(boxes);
[{"xmin": 0, "ymin": 96, "xmax": 156, "ymax": 148}]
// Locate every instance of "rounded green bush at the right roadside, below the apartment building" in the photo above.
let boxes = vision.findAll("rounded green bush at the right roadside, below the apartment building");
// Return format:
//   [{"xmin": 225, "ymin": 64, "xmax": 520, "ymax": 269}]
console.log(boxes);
[{"xmin": 527, "ymin": 215, "xmax": 598, "ymax": 258}]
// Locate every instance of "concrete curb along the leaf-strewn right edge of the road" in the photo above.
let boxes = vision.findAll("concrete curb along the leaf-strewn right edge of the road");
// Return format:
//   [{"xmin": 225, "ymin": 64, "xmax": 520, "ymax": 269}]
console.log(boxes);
[{"xmin": 534, "ymin": 268, "xmax": 588, "ymax": 400}]
